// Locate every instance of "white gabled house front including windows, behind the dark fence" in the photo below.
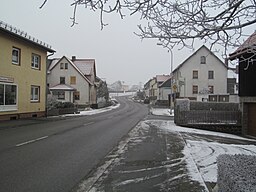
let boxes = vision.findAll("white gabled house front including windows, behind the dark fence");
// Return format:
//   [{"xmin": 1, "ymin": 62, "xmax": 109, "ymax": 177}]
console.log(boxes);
[{"xmin": 172, "ymin": 45, "xmax": 228, "ymax": 101}]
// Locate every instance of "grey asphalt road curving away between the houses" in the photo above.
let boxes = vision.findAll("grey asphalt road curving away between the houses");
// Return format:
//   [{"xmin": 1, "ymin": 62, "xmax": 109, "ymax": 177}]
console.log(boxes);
[{"xmin": 0, "ymin": 98, "xmax": 148, "ymax": 192}]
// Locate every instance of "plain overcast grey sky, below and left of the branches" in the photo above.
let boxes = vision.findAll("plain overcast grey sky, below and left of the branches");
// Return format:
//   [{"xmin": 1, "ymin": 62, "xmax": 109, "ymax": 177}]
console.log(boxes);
[{"xmin": 0, "ymin": 0, "xmax": 236, "ymax": 85}]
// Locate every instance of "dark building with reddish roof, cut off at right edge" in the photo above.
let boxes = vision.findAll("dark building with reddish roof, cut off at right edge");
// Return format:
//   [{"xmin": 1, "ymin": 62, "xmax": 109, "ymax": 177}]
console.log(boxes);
[{"xmin": 229, "ymin": 33, "xmax": 256, "ymax": 137}]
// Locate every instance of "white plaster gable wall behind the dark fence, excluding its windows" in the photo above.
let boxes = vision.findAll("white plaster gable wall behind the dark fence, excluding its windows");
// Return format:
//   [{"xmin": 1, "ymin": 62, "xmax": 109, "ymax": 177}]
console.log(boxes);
[{"xmin": 174, "ymin": 47, "xmax": 227, "ymax": 98}]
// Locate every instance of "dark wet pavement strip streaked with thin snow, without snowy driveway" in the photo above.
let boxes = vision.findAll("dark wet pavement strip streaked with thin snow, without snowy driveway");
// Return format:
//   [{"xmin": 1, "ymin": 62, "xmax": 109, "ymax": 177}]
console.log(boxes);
[{"xmin": 74, "ymin": 118, "xmax": 208, "ymax": 192}]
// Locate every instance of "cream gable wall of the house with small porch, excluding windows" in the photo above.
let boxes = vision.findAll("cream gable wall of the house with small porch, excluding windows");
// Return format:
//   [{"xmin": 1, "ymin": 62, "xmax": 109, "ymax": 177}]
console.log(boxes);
[{"xmin": 47, "ymin": 58, "xmax": 90, "ymax": 105}]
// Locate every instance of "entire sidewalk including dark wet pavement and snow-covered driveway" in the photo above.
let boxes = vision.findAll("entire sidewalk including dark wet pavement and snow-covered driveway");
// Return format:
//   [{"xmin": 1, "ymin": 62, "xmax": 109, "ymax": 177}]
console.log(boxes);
[{"xmin": 73, "ymin": 111, "xmax": 256, "ymax": 192}]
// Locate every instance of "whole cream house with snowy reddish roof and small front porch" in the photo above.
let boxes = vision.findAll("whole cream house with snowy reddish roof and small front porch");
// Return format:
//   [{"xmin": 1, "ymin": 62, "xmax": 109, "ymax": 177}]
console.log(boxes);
[{"xmin": 47, "ymin": 56, "xmax": 97, "ymax": 107}]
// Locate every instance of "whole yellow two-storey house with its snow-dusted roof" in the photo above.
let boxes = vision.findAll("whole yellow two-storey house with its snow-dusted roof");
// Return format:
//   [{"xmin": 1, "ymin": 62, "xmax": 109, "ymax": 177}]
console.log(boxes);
[{"xmin": 0, "ymin": 21, "xmax": 55, "ymax": 120}]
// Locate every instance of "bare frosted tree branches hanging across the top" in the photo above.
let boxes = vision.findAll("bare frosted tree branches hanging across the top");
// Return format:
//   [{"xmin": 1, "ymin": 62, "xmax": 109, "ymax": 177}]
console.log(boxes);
[{"xmin": 42, "ymin": 0, "xmax": 256, "ymax": 53}]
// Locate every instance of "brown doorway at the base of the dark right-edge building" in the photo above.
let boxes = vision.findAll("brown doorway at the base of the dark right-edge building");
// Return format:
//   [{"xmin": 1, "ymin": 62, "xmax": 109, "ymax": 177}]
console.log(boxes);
[{"xmin": 248, "ymin": 103, "xmax": 256, "ymax": 137}]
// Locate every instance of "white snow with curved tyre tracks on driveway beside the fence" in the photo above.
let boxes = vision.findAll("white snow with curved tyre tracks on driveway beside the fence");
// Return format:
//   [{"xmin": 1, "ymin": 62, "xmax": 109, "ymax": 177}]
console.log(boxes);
[{"xmin": 150, "ymin": 120, "xmax": 256, "ymax": 182}]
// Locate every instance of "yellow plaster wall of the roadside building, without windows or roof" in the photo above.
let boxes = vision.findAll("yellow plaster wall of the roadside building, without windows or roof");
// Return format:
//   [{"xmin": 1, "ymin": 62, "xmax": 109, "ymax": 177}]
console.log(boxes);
[{"xmin": 0, "ymin": 32, "xmax": 47, "ymax": 118}]
